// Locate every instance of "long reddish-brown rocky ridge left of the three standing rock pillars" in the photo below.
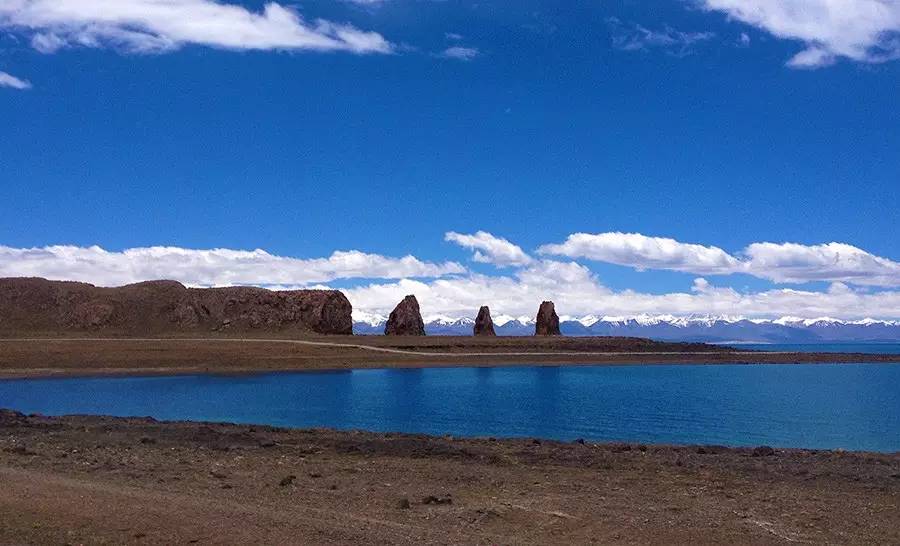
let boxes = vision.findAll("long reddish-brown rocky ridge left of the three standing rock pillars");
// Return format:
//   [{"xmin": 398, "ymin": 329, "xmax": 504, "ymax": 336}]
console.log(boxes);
[{"xmin": 0, "ymin": 278, "xmax": 353, "ymax": 337}]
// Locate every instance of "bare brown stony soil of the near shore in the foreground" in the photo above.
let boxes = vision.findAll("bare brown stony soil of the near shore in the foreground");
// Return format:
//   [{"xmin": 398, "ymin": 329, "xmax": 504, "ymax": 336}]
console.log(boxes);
[{"xmin": 0, "ymin": 411, "xmax": 900, "ymax": 544}]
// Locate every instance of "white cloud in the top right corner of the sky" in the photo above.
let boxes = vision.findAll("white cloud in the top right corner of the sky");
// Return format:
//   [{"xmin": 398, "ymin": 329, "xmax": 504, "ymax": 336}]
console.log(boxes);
[{"xmin": 700, "ymin": 0, "xmax": 900, "ymax": 68}]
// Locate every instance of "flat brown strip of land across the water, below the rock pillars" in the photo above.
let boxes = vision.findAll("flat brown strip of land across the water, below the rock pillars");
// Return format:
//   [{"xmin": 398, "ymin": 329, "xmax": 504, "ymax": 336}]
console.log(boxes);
[{"xmin": 0, "ymin": 336, "xmax": 900, "ymax": 377}]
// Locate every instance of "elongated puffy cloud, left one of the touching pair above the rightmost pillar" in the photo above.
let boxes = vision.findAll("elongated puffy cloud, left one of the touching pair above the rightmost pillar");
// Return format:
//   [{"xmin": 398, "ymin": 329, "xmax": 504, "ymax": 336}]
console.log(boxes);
[{"xmin": 538, "ymin": 232, "xmax": 740, "ymax": 275}]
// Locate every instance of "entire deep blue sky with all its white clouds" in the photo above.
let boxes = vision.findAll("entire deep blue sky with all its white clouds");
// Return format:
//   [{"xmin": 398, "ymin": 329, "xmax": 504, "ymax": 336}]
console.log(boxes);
[{"xmin": 0, "ymin": 0, "xmax": 900, "ymax": 319}]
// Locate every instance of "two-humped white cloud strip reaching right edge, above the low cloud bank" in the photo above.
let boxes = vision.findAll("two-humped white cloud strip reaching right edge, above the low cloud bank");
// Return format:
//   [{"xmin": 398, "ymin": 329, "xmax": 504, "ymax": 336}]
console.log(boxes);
[{"xmin": 538, "ymin": 232, "xmax": 900, "ymax": 287}]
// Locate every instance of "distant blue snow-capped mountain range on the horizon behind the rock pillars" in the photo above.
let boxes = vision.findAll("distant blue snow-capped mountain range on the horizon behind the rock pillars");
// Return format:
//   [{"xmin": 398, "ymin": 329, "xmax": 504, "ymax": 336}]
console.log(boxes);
[{"xmin": 353, "ymin": 311, "xmax": 900, "ymax": 343}]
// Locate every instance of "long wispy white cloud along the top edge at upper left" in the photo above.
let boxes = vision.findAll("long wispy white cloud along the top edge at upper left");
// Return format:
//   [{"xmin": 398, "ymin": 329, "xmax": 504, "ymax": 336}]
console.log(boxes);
[{"xmin": 0, "ymin": 0, "xmax": 392, "ymax": 53}]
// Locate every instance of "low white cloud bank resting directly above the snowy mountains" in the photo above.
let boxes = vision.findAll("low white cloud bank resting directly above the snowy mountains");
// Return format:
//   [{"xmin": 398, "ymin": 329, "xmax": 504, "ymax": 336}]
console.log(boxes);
[{"xmin": 344, "ymin": 268, "xmax": 900, "ymax": 319}]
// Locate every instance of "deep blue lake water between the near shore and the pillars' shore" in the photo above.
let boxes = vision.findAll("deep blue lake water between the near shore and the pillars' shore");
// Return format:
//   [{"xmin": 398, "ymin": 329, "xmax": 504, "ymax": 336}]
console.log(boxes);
[{"xmin": 0, "ymin": 364, "xmax": 900, "ymax": 451}]
